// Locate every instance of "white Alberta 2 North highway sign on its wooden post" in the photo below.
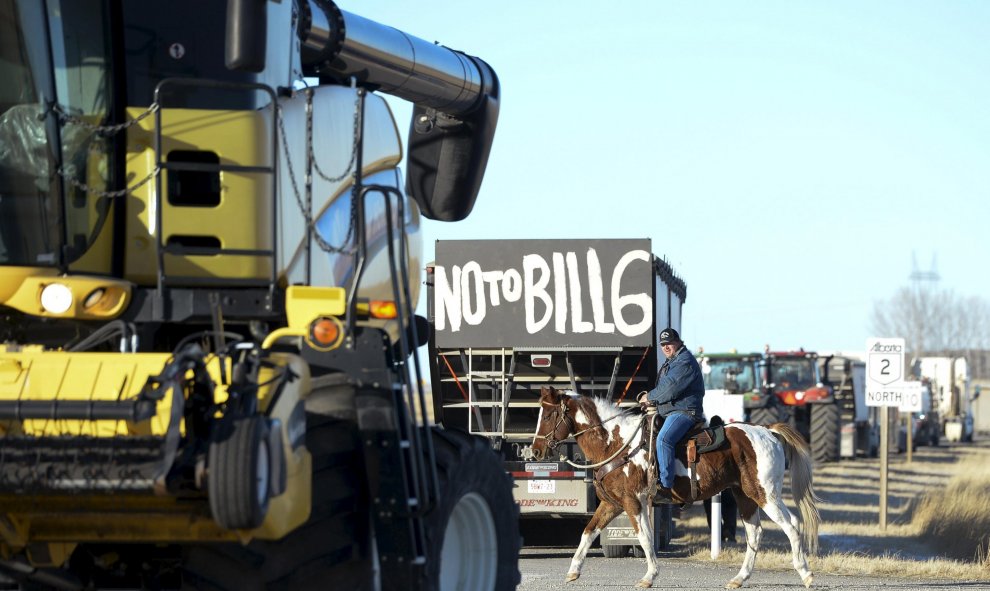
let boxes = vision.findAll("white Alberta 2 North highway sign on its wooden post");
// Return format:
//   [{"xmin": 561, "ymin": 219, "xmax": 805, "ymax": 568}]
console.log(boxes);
[{"xmin": 866, "ymin": 337, "xmax": 904, "ymax": 531}]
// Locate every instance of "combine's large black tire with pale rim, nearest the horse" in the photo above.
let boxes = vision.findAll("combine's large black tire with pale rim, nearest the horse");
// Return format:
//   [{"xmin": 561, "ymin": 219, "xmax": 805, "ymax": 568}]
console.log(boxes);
[{"xmin": 424, "ymin": 427, "xmax": 521, "ymax": 591}]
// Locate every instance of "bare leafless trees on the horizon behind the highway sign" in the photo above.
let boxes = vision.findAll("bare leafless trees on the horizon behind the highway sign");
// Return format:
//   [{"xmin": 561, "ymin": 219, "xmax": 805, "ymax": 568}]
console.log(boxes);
[{"xmin": 871, "ymin": 286, "xmax": 990, "ymax": 355}]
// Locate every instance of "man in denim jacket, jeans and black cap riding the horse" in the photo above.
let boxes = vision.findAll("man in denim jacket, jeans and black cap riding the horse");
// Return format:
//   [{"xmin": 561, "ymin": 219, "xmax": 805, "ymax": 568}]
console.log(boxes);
[{"xmin": 639, "ymin": 328, "xmax": 705, "ymax": 503}]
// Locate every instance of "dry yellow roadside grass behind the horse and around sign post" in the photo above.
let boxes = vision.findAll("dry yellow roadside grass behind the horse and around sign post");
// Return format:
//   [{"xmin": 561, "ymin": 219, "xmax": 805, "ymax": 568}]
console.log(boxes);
[{"xmin": 674, "ymin": 442, "xmax": 990, "ymax": 581}]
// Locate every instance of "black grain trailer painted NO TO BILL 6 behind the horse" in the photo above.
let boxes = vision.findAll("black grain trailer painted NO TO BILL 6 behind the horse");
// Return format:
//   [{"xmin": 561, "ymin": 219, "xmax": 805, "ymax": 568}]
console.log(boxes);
[{"xmin": 427, "ymin": 239, "xmax": 686, "ymax": 556}]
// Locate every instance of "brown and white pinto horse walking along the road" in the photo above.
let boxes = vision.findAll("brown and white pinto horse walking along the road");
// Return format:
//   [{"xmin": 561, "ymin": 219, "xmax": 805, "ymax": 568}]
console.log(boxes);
[{"xmin": 532, "ymin": 386, "xmax": 821, "ymax": 589}]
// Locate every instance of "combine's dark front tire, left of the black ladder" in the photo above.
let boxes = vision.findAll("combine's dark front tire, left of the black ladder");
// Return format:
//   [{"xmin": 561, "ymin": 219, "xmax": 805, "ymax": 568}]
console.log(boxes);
[{"xmin": 182, "ymin": 413, "xmax": 377, "ymax": 591}]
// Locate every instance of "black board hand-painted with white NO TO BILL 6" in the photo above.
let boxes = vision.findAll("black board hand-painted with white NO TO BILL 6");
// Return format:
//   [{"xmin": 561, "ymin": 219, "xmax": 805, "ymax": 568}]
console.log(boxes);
[{"xmin": 432, "ymin": 240, "xmax": 655, "ymax": 348}]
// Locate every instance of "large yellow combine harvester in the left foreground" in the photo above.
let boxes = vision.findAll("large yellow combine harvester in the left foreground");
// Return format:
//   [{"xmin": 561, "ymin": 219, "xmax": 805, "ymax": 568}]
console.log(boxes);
[{"xmin": 0, "ymin": 0, "xmax": 519, "ymax": 590}]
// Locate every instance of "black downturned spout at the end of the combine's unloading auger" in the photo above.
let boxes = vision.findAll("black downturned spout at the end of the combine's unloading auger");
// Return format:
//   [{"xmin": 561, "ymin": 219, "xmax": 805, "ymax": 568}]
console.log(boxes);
[{"xmin": 406, "ymin": 58, "xmax": 499, "ymax": 222}]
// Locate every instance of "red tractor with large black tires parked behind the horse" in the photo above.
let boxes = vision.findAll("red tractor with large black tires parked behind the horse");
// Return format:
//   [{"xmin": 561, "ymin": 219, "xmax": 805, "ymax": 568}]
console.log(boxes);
[{"xmin": 746, "ymin": 347, "xmax": 840, "ymax": 462}]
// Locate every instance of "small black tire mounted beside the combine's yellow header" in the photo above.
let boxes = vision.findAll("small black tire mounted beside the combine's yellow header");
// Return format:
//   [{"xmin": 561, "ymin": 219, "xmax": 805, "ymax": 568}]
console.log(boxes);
[{"xmin": 207, "ymin": 416, "xmax": 271, "ymax": 529}]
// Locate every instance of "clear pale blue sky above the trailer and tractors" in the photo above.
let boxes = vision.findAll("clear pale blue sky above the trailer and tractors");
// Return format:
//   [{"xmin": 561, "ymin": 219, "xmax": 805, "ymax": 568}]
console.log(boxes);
[{"xmin": 340, "ymin": 0, "xmax": 990, "ymax": 351}]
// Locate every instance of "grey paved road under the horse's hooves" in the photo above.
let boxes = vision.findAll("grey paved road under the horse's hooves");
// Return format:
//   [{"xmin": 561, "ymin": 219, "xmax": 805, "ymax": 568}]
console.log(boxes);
[{"xmin": 517, "ymin": 548, "xmax": 990, "ymax": 591}]
